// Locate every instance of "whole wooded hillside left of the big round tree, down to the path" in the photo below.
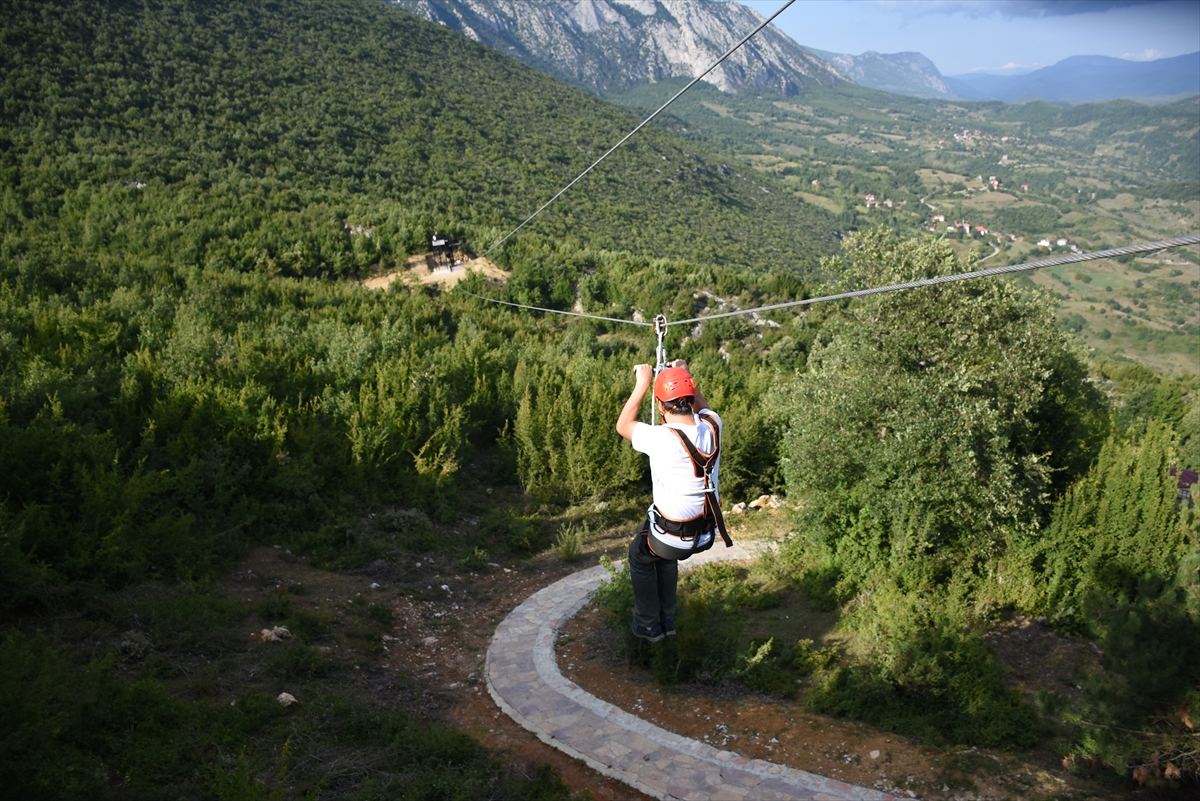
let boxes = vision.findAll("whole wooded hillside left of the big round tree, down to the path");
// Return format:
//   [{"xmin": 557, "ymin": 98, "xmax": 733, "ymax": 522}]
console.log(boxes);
[{"xmin": 0, "ymin": 0, "xmax": 834, "ymax": 801}]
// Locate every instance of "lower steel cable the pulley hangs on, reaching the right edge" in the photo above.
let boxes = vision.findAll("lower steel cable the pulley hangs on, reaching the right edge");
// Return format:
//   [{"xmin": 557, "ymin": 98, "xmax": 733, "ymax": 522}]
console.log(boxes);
[{"xmin": 462, "ymin": 234, "xmax": 1200, "ymax": 327}]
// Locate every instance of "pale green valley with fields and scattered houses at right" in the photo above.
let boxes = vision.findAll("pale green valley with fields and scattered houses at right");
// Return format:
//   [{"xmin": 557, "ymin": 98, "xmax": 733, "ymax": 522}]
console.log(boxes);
[{"xmin": 613, "ymin": 82, "xmax": 1200, "ymax": 373}]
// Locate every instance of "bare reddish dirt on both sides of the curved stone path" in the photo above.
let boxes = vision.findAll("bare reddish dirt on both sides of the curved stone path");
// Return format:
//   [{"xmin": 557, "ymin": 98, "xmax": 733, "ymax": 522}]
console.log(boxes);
[{"xmin": 222, "ymin": 519, "xmax": 1148, "ymax": 801}]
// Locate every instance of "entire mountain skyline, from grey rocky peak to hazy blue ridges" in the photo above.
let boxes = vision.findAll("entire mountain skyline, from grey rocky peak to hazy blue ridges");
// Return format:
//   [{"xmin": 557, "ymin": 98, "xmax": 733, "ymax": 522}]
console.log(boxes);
[{"xmin": 389, "ymin": 0, "xmax": 1200, "ymax": 103}]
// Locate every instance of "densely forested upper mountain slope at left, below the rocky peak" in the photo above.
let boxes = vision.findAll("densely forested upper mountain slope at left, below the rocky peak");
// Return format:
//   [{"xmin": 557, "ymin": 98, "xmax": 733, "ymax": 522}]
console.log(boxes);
[{"xmin": 0, "ymin": 2, "xmax": 834, "ymax": 281}]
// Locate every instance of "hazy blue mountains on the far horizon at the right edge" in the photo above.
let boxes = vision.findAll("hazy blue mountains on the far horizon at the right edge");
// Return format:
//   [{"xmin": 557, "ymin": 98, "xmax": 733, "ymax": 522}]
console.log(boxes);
[{"xmin": 946, "ymin": 52, "xmax": 1200, "ymax": 103}]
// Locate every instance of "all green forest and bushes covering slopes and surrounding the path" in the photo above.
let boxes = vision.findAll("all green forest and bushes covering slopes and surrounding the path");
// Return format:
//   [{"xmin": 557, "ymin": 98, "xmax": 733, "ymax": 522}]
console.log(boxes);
[{"xmin": 0, "ymin": 0, "xmax": 1200, "ymax": 799}]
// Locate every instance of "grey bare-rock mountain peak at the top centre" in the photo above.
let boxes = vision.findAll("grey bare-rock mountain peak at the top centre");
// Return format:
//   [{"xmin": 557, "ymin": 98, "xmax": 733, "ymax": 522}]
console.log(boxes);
[{"xmin": 391, "ymin": 0, "xmax": 845, "ymax": 95}]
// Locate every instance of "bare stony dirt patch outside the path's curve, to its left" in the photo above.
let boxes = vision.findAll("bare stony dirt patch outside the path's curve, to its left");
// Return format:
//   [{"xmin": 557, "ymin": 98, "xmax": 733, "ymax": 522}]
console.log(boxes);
[{"xmin": 220, "ymin": 538, "xmax": 646, "ymax": 801}]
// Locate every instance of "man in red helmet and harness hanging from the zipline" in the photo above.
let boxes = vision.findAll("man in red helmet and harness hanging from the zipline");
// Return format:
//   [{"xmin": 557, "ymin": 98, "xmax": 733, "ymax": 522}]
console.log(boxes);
[{"xmin": 617, "ymin": 360, "xmax": 733, "ymax": 643}]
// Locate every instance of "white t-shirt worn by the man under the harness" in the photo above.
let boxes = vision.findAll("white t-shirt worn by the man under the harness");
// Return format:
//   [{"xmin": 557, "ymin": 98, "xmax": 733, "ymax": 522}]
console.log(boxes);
[{"xmin": 632, "ymin": 409, "xmax": 724, "ymax": 520}]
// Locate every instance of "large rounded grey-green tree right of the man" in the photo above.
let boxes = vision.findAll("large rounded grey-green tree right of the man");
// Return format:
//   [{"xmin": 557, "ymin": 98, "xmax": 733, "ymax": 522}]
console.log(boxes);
[{"xmin": 784, "ymin": 230, "xmax": 1100, "ymax": 589}]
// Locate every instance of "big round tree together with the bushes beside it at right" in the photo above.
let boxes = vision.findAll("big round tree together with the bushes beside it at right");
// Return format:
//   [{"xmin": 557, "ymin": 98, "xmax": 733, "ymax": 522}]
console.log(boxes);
[{"xmin": 753, "ymin": 233, "xmax": 1200, "ymax": 770}]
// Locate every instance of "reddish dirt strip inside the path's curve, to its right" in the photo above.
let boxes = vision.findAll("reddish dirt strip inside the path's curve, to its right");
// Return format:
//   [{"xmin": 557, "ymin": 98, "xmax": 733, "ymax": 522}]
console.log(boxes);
[{"xmin": 558, "ymin": 599, "xmax": 1129, "ymax": 801}]
